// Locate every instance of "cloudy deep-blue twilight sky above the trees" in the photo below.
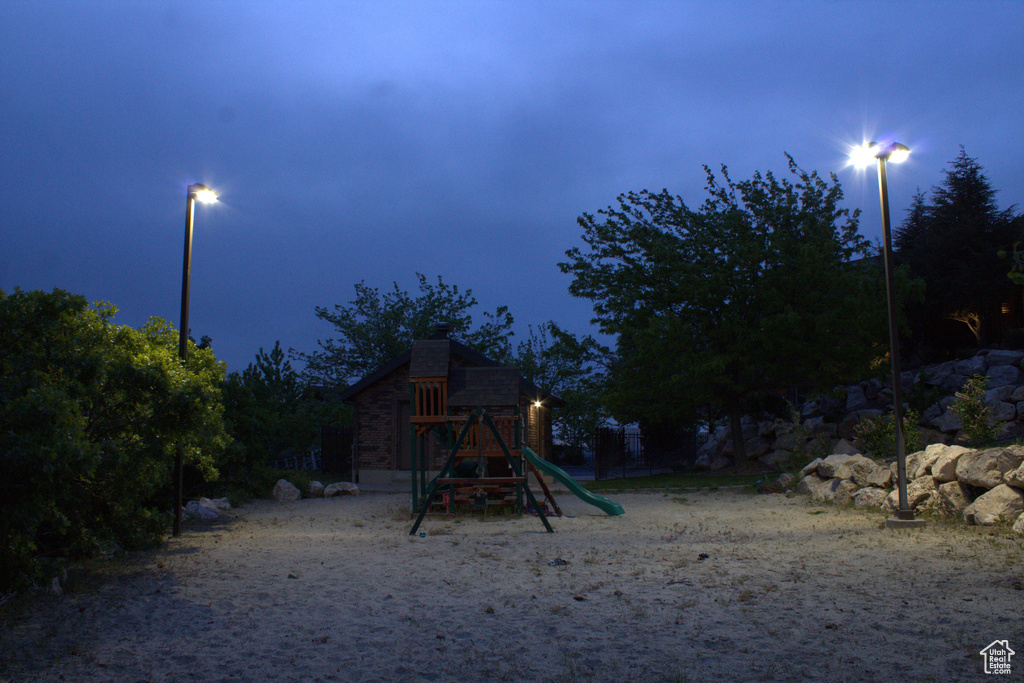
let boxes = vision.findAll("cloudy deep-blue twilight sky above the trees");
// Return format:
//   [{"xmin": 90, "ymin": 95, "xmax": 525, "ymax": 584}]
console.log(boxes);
[{"xmin": 0, "ymin": 0, "xmax": 1024, "ymax": 370}]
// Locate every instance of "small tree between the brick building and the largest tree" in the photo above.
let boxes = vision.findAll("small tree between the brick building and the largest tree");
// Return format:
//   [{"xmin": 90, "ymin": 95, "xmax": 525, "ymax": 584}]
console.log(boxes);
[{"xmin": 514, "ymin": 321, "xmax": 609, "ymax": 446}]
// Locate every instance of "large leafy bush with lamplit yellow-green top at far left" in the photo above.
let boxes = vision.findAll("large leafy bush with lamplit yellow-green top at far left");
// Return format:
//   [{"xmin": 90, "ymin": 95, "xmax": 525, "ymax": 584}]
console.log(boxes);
[{"xmin": 0, "ymin": 289, "xmax": 229, "ymax": 591}]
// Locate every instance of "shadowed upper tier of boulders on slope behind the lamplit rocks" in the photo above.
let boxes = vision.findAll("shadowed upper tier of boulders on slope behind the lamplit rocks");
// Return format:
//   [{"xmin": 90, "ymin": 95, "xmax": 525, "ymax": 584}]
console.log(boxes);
[{"xmin": 696, "ymin": 349, "xmax": 1024, "ymax": 470}]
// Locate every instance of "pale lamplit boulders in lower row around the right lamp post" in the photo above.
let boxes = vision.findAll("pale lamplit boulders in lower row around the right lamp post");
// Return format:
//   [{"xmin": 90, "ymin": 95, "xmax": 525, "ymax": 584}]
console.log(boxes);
[{"xmin": 796, "ymin": 443, "xmax": 1024, "ymax": 533}]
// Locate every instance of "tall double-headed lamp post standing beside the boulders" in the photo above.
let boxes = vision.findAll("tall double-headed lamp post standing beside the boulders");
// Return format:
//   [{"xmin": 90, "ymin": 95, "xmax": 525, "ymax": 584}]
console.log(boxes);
[{"xmin": 850, "ymin": 142, "xmax": 925, "ymax": 527}]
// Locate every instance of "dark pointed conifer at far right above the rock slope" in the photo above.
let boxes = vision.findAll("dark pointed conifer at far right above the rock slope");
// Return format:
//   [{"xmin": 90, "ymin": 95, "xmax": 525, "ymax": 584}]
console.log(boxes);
[{"xmin": 896, "ymin": 147, "xmax": 1019, "ymax": 345}]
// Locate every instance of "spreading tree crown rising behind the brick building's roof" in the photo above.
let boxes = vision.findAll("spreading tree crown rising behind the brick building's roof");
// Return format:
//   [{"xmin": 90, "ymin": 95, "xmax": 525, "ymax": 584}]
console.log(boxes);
[{"xmin": 297, "ymin": 273, "xmax": 513, "ymax": 387}]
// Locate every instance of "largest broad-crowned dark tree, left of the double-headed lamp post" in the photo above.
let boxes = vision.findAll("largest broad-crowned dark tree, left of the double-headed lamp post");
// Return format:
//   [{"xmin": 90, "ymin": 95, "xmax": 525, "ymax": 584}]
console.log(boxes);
[{"xmin": 559, "ymin": 156, "xmax": 886, "ymax": 463}]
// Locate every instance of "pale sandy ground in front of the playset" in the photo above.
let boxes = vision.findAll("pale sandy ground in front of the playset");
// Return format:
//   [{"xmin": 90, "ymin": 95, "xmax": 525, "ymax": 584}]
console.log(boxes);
[{"xmin": 0, "ymin": 492, "xmax": 1024, "ymax": 681}]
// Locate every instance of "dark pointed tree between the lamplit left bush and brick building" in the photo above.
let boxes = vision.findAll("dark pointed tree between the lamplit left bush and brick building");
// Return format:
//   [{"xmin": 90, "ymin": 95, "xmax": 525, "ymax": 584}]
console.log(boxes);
[{"xmin": 221, "ymin": 341, "xmax": 349, "ymax": 485}]
